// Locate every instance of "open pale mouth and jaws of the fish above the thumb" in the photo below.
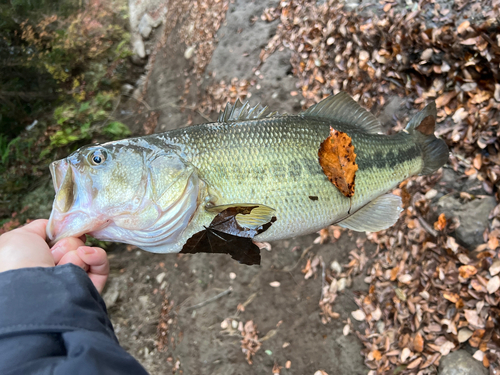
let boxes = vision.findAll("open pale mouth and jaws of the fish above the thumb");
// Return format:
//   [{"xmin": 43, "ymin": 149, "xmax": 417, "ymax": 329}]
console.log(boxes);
[{"xmin": 46, "ymin": 159, "xmax": 103, "ymax": 246}]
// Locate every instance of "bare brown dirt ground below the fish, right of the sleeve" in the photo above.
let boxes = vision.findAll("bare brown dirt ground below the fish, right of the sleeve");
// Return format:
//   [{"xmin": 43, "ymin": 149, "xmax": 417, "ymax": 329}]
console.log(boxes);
[{"xmin": 105, "ymin": 235, "xmax": 374, "ymax": 374}]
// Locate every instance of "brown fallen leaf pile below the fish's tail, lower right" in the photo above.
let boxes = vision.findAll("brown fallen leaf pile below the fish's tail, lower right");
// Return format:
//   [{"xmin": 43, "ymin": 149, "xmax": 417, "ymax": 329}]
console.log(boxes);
[{"xmin": 344, "ymin": 177, "xmax": 500, "ymax": 374}]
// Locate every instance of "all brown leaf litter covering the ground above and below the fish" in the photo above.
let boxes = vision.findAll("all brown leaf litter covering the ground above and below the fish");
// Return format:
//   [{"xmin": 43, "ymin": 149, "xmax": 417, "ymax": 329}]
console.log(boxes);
[{"xmin": 111, "ymin": 0, "xmax": 500, "ymax": 374}]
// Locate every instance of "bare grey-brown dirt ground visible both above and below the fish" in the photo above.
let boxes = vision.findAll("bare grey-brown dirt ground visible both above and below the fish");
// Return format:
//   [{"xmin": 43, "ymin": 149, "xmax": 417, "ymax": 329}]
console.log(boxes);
[{"xmin": 104, "ymin": 1, "xmax": 376, "ymax": 375}]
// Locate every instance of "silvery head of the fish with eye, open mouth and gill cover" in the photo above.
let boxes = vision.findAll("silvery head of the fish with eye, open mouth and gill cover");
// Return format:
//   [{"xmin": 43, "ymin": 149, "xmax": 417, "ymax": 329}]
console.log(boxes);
[{"xmin": 47, "ymin": 142, "xmax": 199, "ymax": 246}]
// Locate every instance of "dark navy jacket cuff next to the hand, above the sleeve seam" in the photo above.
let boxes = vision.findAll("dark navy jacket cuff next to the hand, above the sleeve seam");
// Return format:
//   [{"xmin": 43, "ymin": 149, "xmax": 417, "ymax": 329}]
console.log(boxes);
[{"xmin": 0, "ymin": 264, "xmax": 117, "ymax": 341}]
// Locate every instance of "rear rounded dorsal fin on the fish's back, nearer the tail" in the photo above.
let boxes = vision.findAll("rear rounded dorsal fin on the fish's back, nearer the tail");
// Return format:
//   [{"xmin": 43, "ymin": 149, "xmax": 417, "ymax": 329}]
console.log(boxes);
[{"xmin": 302, "ymin": 91, "xmax": 382, "ymax": 134}]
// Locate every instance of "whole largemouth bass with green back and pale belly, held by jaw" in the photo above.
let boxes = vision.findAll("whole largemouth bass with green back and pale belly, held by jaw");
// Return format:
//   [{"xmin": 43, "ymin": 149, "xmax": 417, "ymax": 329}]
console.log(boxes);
[{"xmin": 47, "ymin": 92, "xmax": 449, "ymax": 253}]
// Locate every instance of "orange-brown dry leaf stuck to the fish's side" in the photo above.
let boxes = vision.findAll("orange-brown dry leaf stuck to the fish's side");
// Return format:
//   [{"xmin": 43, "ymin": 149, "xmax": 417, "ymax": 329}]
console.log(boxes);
[{"xmin": 318, "ymin": 127, "xmax": 358, "ymax": 197}]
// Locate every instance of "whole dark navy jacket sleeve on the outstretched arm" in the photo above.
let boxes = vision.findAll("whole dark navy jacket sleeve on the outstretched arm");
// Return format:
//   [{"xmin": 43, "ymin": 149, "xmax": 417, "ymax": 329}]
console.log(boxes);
[{"xmin": 0, "ymin": 264, "xmax": 147, "ymax": 375}]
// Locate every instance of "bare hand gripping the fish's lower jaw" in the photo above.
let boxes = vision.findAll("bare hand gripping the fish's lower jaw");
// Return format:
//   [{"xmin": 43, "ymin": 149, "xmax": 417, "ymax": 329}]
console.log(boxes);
[{"xmin": 0, "ymin": 219, "xmax": 109, "ymax": 293}]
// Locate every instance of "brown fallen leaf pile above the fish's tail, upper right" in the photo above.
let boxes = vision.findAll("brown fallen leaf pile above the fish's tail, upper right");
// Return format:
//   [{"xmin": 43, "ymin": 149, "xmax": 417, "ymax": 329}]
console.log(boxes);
[{"xmin": 261, "ymin": 0, "xmax": 500, "ymax": 203}]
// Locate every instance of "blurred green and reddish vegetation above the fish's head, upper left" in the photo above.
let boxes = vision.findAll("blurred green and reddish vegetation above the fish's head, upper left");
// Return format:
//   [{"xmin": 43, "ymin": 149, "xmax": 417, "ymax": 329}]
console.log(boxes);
[{"xmin": 0, "ymin": 0, "xmax": 131, "ymax": 231}]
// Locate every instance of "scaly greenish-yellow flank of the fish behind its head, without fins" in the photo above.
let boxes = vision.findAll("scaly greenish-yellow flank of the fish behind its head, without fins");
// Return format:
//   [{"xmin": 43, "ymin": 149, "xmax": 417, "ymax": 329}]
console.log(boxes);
[{"xmin": 156, "ymin": 116, "xmax": 422, "ymax": 241}]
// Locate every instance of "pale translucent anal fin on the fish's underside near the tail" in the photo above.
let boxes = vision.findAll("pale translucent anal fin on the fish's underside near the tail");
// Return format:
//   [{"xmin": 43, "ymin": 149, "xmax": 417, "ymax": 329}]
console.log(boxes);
[{"xmin": 337, "ymin": 194, "xmax": 403, "ymax": 232}]
